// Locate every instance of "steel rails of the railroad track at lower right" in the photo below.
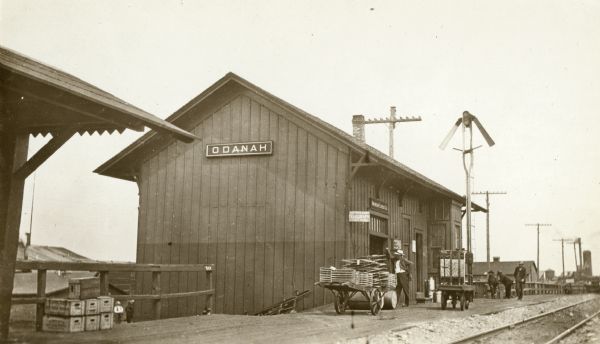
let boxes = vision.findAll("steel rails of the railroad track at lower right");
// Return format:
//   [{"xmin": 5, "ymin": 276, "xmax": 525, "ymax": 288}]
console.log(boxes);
[{"xmin": 450, "ymin": 298, "xmax": 600, "ymax": 344}]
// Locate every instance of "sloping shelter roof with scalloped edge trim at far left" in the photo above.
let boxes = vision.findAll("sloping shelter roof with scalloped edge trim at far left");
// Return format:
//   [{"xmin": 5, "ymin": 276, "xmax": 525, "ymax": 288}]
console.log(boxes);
[{"xmin": 0, "ymin": 46, "xmax": 197, "ymax": 142}]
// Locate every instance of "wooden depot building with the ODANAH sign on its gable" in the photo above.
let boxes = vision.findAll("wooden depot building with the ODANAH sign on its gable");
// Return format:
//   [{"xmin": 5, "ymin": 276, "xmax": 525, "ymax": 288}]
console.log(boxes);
[{"xmin": 96, "ymin": 73, "xmax": 482, "ymax": 317}]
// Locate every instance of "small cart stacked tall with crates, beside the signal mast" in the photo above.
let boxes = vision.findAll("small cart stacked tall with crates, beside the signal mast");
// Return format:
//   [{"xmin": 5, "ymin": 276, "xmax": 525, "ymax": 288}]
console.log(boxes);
[{"xmin": 439, "ymin": 250, "xmax": 475, "ymax": 311}]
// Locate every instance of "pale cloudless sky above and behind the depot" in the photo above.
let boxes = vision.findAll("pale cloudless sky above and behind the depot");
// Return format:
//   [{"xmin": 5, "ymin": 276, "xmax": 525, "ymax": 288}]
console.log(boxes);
[{"xmin": 0, "ymin": 0, "xmax": 600, "ymax": 274}]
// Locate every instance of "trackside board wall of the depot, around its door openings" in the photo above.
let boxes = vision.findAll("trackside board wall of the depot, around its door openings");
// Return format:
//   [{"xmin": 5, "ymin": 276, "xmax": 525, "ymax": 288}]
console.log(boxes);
[{"xmin": 348, "ymin": 172, "xmax": 429, "ymax": 300}]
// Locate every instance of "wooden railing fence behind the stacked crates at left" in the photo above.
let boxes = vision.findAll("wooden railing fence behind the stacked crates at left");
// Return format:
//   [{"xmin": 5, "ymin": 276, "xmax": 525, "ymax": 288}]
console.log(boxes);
[{"xmin": 12, "ymin": 260, "xmax": 215, "ymax": 331}]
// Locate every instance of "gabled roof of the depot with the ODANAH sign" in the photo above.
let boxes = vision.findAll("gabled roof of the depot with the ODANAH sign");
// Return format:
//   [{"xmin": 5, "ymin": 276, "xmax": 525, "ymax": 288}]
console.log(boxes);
[{"xmin": 94, "ymin": 72, "xmax": 485, "ymax": 211}]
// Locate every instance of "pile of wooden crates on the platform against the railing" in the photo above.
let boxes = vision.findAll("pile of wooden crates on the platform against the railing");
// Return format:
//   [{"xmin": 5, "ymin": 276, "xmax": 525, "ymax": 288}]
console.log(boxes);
[{"xmin": 43, "ymin": 277, "xmax": 114, "ymax": 332}]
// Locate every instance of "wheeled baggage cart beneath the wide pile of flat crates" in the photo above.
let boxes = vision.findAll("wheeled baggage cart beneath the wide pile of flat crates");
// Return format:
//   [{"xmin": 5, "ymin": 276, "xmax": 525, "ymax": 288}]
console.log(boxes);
[{"xmin": 315, "ymin": 282, "xmax": 391, "ymax": 315}]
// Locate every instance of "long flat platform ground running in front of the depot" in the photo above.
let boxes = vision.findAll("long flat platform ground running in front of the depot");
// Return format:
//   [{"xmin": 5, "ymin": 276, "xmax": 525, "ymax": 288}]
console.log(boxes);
[{"xmin": 10, "ymin": 295, "xmax": 577, "ymax": 344}]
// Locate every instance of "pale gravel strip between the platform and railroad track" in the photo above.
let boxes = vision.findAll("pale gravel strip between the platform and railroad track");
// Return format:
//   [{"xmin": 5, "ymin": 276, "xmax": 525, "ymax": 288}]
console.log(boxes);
[{"xmin": 347, "ymin": 294, "xmax": 600, "ymax": 344}]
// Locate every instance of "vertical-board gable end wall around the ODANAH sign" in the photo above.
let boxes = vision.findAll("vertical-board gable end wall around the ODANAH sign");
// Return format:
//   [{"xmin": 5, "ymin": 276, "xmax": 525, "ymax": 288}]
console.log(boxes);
[{"xmin": 136, "ymin": 92, "xmax": 348, "ymax": 317}]
